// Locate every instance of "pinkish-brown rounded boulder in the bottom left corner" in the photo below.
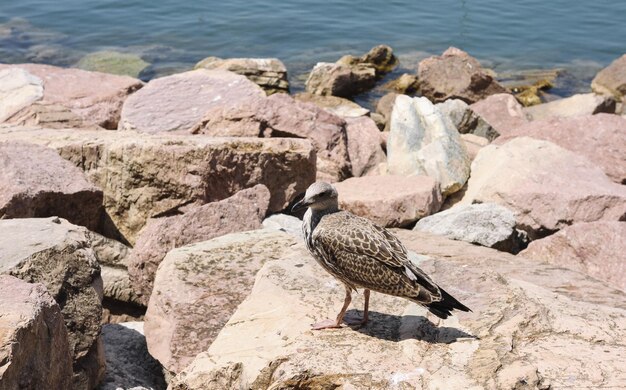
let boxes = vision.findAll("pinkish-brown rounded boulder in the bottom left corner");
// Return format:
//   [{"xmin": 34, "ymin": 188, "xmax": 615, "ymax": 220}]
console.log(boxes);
[{"xmin": 0, "ymin": 275, "xmax": 72, "ymax": 390}]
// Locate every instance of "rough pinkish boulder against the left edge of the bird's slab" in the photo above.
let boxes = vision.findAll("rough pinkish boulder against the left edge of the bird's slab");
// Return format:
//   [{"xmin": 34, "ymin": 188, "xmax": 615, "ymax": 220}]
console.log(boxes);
[{"xmin": 145, "ymin": 230, "xmax": 295, "ymax": 373}]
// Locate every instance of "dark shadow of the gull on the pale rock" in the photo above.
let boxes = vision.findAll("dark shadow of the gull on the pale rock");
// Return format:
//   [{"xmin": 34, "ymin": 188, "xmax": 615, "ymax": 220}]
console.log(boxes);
[{"xmin": 346, "ymin": 310, "xmax": 478, "ymax": 344}]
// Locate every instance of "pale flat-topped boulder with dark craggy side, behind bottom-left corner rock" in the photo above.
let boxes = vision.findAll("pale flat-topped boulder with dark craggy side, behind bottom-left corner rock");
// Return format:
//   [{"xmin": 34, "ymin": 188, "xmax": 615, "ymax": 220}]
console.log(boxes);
[{"xmin": 0, "ymin": 217, "xmax": 104, "ymax": 389}]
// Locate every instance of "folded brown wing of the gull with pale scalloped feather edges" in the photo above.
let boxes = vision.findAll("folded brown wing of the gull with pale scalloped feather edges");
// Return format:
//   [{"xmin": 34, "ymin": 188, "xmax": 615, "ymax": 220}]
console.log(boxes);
[{"xmin": 313, "ymin": 212, "xmax": 440, "ymax": 299}]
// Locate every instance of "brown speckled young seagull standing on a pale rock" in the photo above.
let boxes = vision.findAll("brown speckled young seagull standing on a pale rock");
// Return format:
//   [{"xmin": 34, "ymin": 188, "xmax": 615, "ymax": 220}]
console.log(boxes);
[{"xmin": 292, "ymin": 182, "xmax": 470, "ymax": 329}]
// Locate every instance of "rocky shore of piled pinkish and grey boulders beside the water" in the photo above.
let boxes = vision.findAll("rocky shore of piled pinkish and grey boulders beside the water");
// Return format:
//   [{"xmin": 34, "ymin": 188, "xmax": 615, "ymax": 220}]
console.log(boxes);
[{"xmin": 0, "ymin": 45, "xmax": 626, "ymax": 390}]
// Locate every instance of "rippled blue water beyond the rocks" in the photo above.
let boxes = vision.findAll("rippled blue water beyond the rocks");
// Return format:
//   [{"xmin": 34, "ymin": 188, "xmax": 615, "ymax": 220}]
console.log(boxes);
[{"xmin": 0, "ymin": 0, "xmax": 626, "ymax": 90}]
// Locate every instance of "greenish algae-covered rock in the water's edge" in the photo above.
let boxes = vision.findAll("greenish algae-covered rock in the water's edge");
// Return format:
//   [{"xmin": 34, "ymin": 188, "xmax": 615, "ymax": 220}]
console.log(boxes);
[{"xmin": 76, "ymin": 50, "xmax": 150, "ymax": 78}]
